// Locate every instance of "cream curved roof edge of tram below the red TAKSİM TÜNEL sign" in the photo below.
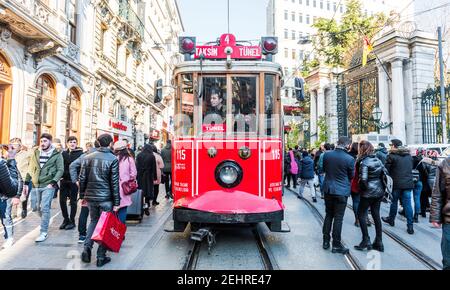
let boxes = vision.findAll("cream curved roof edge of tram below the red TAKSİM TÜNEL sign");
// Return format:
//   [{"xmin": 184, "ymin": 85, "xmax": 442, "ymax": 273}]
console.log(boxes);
[{"xmin": 174, "ymin": 60, "xmax": 283, "ymax": 75}]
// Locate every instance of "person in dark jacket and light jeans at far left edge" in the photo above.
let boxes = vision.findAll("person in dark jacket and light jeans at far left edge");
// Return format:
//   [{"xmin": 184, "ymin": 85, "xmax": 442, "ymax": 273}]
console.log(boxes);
[{"xmin": 0, "ymin": 144, "xmax": 22, "ymax": 249}]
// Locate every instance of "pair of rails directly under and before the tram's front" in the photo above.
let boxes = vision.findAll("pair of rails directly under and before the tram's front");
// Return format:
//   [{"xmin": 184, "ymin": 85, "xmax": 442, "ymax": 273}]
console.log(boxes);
[{"xmin": 183, "ymin": 225, "xmax": 280, "ymax": 270}]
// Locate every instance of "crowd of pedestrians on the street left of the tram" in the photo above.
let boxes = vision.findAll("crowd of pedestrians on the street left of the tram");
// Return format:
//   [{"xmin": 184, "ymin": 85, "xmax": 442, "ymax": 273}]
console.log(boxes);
[{"xmin": 0, "ymin": 133, "xmax": 173, "ymax": 267}]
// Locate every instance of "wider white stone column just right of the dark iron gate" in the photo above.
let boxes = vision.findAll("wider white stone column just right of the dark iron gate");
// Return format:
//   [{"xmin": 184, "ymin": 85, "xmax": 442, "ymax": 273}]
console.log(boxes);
[{"xmin": 392, "ymin": 58, "xmax": 406, "ymax": 143}]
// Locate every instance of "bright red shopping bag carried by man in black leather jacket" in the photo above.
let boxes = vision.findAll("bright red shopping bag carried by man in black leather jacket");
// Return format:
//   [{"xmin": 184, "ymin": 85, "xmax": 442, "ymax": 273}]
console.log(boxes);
[{"xmin": 91, "ymin": 211, "xmax": 127, "ymax": 253}]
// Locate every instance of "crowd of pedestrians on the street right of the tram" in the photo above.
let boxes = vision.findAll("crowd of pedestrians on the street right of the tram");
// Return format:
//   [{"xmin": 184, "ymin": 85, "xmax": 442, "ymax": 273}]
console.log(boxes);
[{"xmin": 284, "ymin": 137, "xmax": 450, "ymax": 270}]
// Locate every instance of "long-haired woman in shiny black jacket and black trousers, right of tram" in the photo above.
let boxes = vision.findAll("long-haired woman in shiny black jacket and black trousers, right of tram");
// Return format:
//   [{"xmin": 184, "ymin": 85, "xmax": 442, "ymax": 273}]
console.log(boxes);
[{"xmin": 355, "ymin": 141, "xmax": 388, "ymax": 252}]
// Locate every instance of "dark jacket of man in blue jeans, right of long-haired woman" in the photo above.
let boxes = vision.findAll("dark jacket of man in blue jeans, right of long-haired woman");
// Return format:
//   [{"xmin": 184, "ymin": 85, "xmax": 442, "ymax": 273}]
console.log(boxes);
[{"xmin": 385, "ymin": 147, "xmax": 414, "ymax": 190}]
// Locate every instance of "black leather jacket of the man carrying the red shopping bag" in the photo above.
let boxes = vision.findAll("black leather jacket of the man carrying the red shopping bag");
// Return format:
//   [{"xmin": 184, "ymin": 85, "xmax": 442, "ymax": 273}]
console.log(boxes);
[{"xmin": 80, "ymin": 147, "xmax": 120, "ymax": 206}]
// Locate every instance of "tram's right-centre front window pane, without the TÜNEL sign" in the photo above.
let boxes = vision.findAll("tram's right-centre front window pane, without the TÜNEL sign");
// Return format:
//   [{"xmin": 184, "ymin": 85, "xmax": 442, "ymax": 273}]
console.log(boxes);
[{"xmin": 231, "ymin": 77, "xmax": 257, "ymax": 133}]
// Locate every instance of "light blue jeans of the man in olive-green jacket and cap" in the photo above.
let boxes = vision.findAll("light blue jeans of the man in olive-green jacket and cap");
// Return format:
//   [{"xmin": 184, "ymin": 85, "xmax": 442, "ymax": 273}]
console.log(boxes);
[{"xmin": 30, "ymin": 187, "xmax": 55, "ymax": 233}]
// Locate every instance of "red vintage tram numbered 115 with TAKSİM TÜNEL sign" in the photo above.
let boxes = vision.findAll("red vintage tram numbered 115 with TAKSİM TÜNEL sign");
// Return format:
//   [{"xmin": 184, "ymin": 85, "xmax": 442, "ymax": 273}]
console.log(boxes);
[{"xmin": 172, "ymin": 34, "xmax": 284, "ymax": 231}]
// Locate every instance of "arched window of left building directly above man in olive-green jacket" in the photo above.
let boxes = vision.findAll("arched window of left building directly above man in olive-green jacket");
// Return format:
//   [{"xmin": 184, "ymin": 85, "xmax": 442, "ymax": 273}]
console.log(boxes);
[{"xmin": 34, "ymin": 74, "xmax": 56, "ymax": 144}]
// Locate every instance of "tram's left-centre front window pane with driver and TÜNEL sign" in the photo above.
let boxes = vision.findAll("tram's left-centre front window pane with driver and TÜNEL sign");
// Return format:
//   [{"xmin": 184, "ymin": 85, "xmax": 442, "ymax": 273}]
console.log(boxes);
[{"xmin": 202, "ymin": 77, "xmax": 227, "ymax": 133}]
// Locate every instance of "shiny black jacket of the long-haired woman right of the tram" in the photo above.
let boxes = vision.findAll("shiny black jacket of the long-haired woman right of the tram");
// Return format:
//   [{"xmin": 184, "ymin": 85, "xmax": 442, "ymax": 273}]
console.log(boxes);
[{"xmin": 358, "ymin": 155, "xmax": 387, "ymax": 198}]
